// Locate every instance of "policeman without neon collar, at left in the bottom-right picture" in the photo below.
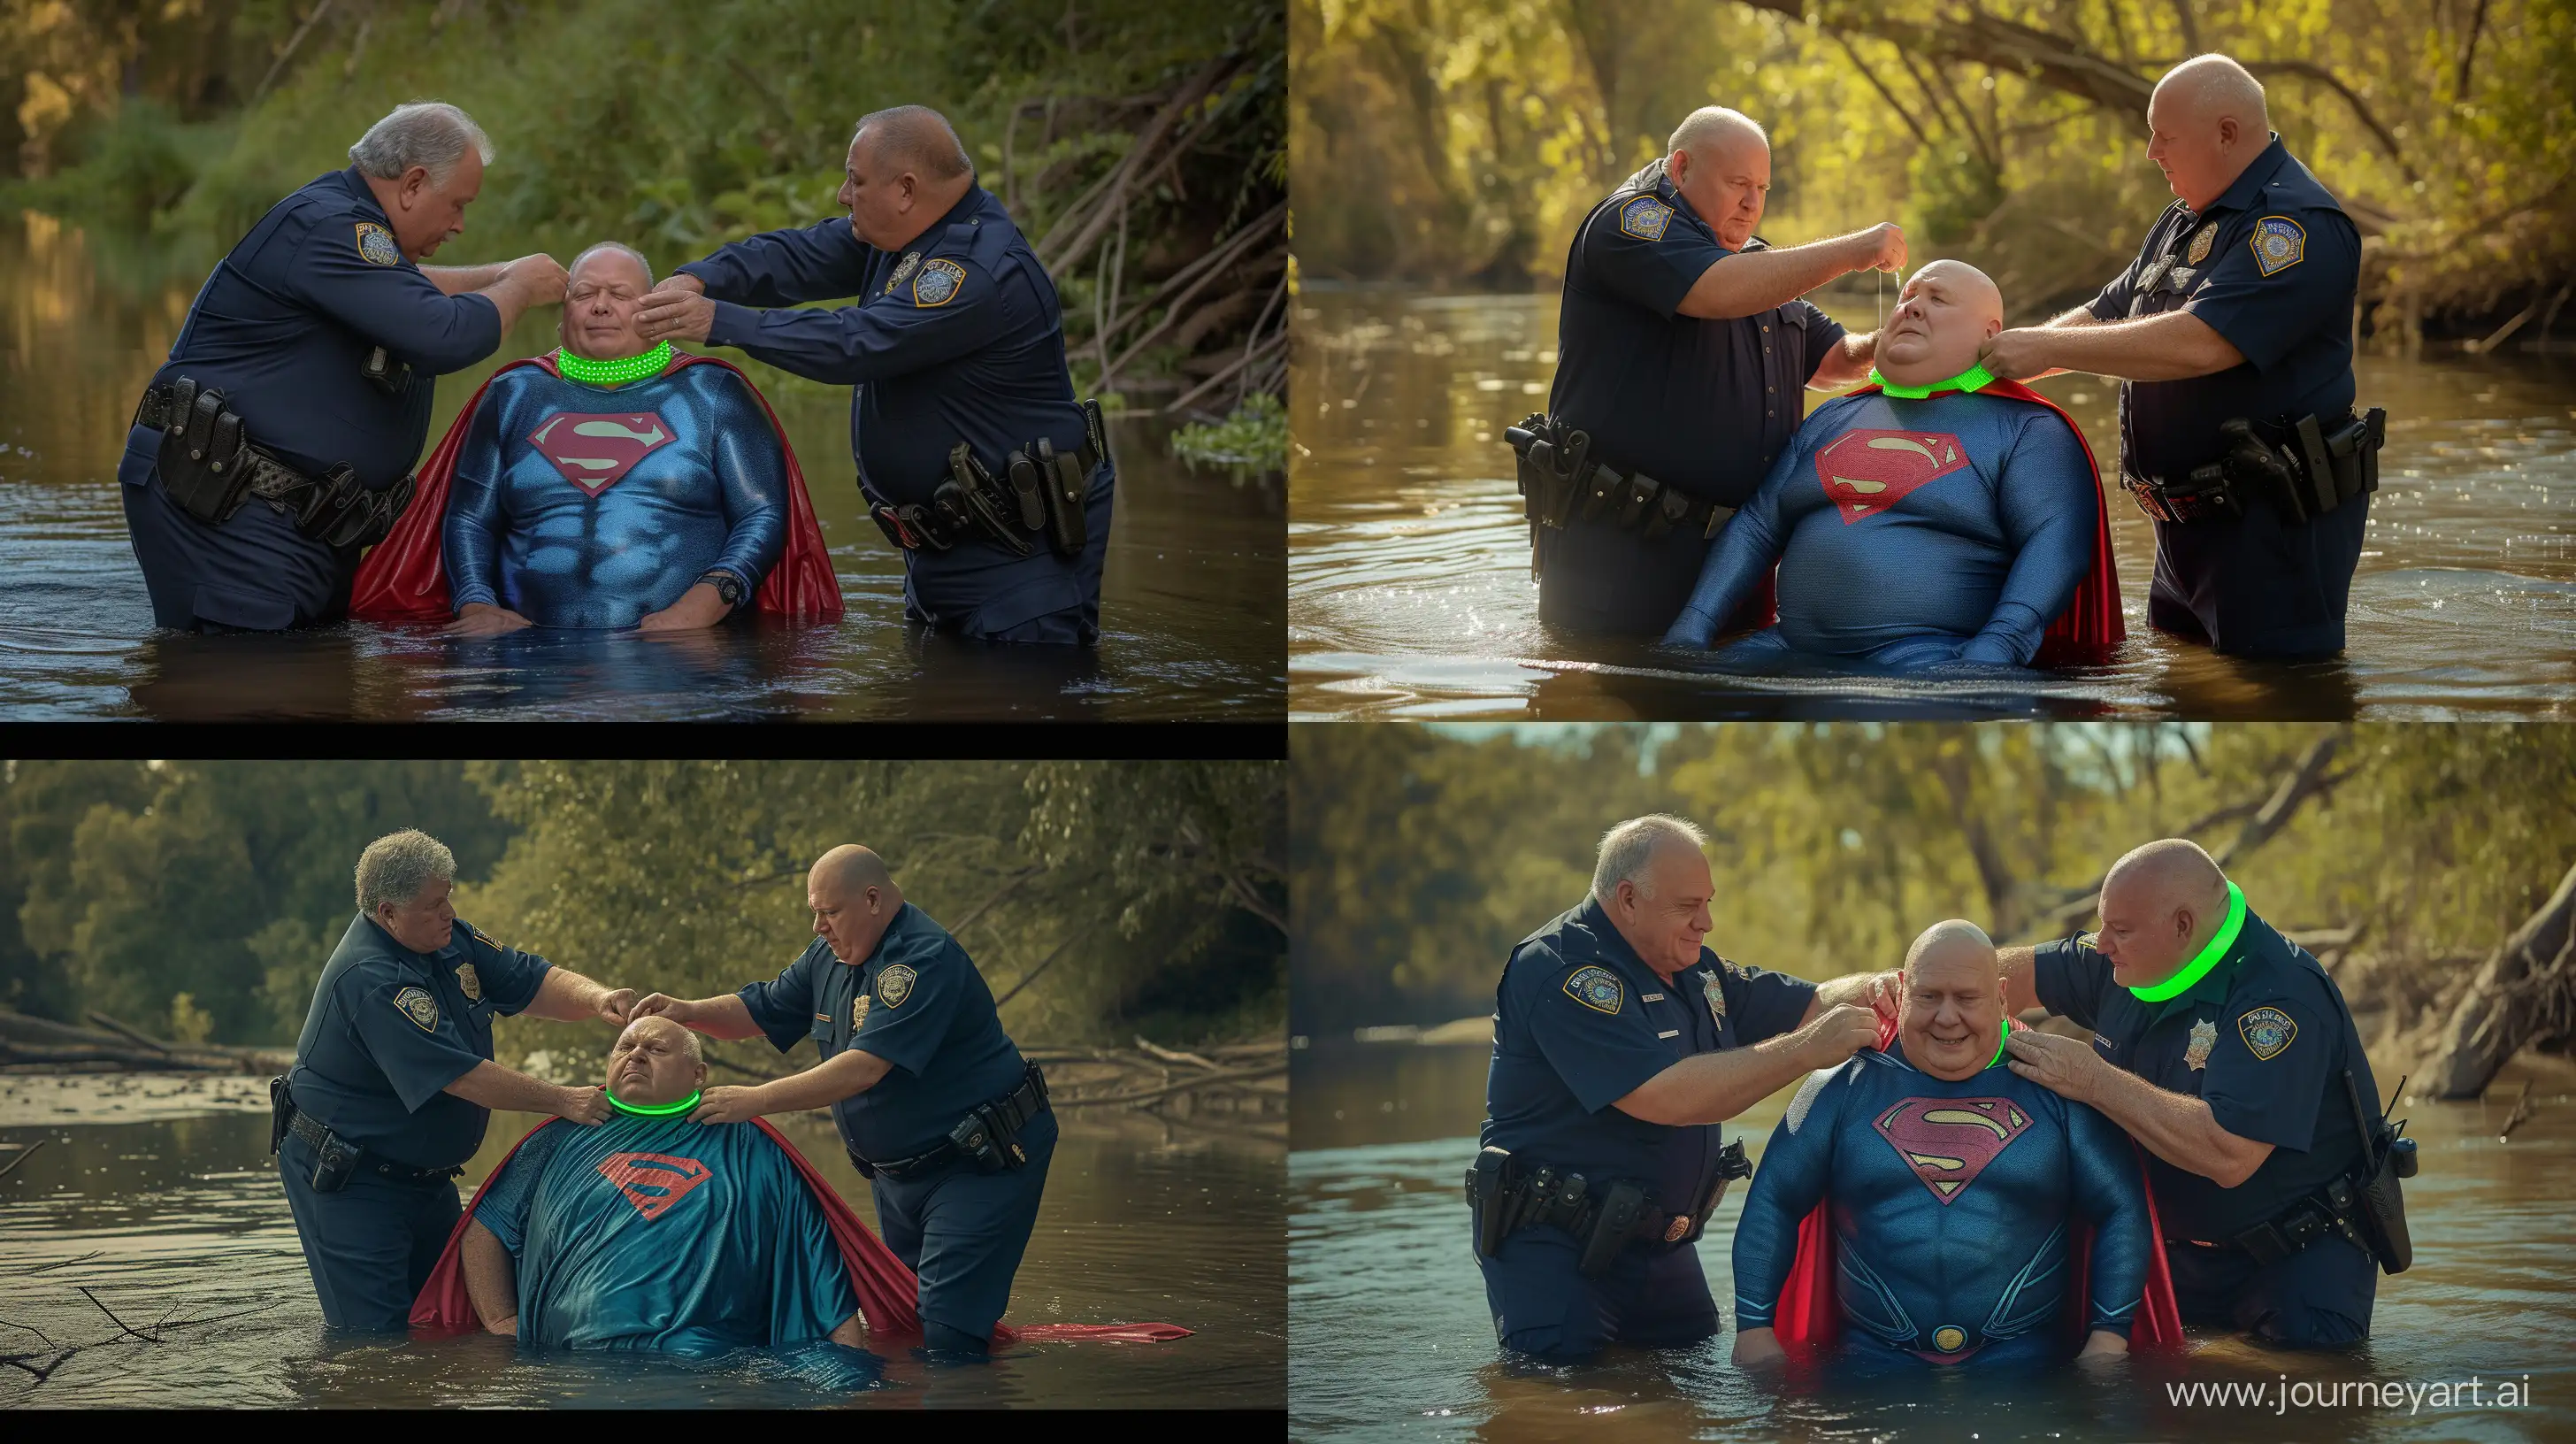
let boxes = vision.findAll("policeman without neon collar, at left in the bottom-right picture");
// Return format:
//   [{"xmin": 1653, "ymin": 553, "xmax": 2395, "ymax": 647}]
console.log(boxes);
[{"xmin": 1468, "ymin": 815, "xmax": 1881, "ymax": 1362}]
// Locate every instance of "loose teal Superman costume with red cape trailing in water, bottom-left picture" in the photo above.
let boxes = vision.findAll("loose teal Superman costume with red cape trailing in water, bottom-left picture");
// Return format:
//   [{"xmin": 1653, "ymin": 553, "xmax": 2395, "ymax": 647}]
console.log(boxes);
[{"xmin": 410, "ymin": 1114, "xmax": 1190, "ymax": 1354}]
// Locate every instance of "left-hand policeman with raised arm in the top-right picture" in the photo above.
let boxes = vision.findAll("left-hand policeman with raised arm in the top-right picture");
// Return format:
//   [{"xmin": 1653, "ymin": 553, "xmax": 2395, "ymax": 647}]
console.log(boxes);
[{"xmin": 1512, "ymin": 105, "xmax": 1906, "ymax": 637}]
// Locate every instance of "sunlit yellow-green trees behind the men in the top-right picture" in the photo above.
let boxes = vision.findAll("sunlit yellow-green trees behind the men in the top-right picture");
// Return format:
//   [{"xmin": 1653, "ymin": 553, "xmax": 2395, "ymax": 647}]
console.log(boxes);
[{"xmin": 1288, "ymin": 0, "xmax": 2576, "ymax": 338}]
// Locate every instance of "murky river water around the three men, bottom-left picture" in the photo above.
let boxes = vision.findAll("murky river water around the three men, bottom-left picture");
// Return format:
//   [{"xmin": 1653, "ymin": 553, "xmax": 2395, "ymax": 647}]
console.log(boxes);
[{"xmin": 0, "ymin": 1075, "xmax": 1285, "ymax": 1410}]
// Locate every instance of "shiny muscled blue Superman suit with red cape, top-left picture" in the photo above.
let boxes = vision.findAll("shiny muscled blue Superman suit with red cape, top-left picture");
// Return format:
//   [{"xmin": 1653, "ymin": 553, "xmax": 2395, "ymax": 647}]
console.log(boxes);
[{"xmin": 350, "ymin": 353, "xmax": 842, "ymax": 626}]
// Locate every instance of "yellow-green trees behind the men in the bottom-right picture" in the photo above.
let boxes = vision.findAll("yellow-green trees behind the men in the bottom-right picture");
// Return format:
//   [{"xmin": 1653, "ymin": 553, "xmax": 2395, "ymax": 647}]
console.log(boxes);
[{"xmin": 1291, "ymin": 725, "xmax": 2576, "ymax": 1032}]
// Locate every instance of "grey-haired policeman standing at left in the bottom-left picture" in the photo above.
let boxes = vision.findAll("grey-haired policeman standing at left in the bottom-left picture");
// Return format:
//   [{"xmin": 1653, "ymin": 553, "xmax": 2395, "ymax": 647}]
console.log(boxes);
[{"xmin": 268, "ymin": 830, "xmax": 633, "ymax": 1331}]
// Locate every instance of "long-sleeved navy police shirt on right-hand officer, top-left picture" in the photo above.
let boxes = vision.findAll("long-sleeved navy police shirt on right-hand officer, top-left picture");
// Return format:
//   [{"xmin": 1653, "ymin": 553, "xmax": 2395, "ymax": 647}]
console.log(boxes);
[{"xmin": 680, "ymin": 186, "xmax": 1085, "ymax": 505}]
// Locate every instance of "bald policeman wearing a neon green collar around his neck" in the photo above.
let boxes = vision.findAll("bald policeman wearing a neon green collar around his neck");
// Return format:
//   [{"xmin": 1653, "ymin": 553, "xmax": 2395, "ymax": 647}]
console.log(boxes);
[{"xmin": 2002, "ymin": 838, "xmax": 2411, "ymax": 1348}]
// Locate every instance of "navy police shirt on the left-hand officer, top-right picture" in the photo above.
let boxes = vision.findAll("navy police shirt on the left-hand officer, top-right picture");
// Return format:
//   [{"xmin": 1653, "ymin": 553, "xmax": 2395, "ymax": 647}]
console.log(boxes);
[{"xmin": 1548, "ymin": 160, "xmax": 1842, "ymax": 505}]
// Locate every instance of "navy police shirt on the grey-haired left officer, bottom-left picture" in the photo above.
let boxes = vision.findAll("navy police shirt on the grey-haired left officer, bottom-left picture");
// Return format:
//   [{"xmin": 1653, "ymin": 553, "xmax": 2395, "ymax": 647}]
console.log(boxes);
[{"xmin": 288, "ymin": 913, "xmax": 551, "ymax": 1168}]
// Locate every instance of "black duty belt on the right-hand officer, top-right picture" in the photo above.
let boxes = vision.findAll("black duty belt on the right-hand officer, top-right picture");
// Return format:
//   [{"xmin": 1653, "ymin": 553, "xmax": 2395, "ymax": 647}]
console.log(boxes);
[{"xmin": 2120, "ymin": 407, "xmax": 2388, "ymax": 524}]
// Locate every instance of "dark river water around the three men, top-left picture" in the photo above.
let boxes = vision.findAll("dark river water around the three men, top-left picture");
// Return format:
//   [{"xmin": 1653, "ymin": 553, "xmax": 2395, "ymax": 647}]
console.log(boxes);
[{"xmin": 0, "ymin": 211, "xmax": 1288, "ymax": 722}]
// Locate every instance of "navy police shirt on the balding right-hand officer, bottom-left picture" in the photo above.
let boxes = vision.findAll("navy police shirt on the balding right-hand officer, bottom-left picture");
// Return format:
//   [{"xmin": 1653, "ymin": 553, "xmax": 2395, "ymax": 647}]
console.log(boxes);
[{"xmin": 737, "ymin": 902, "xmax": 1025, "ymax": 1163}]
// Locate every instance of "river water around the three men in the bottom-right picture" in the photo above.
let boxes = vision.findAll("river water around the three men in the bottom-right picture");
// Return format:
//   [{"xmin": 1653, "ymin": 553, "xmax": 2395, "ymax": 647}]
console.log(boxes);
[{"xmin": 1288, "ymin": 1044, "xmax": 2576, "ymax": 1444}]
